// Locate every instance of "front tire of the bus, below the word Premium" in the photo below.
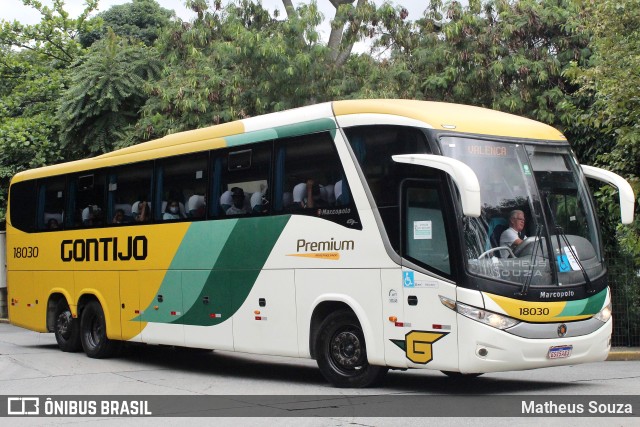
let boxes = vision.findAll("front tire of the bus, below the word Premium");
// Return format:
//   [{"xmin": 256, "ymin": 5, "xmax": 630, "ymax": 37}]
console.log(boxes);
[{"xmin": 316, "ymin": 311, "xmax": 389, "ymax": 388}]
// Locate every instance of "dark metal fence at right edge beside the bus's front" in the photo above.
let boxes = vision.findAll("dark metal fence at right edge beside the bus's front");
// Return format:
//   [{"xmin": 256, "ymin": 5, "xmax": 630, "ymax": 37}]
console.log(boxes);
[{"xmin": 607, "ymin": 254, "xmax": 640, "ymax": 347}]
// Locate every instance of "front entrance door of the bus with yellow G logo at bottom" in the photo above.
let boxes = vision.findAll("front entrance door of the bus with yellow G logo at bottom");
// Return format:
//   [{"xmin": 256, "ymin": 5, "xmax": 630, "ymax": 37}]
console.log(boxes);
[{"xmin": 400, "ymin": 179, "xmax": 458, "ymax": 370}]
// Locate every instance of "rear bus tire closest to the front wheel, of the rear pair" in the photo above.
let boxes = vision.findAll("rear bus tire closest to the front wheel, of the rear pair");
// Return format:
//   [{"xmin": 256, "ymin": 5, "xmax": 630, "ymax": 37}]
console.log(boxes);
[{"xmin": 80, "ymin": 301, "xmax": 118, "ymax": 359}]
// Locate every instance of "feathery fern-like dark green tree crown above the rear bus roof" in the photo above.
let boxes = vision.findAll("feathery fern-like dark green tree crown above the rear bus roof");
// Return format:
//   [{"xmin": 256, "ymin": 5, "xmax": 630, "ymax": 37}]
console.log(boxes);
[{"xmin": 56, "ymin": 30, "xmax": 161, "ymax": 158}]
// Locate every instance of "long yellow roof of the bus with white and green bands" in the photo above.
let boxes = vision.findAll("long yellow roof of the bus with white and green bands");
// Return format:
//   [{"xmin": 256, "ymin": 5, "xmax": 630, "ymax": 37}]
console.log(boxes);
[{"xmin": 14, "ymin": 99, "xmax": 566, "ymax": 182}]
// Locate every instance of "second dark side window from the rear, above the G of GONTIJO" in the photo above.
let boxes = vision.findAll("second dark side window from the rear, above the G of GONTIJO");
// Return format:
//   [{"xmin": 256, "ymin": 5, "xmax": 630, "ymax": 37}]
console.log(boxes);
[{"xmin": 36, "ymin": 176, "xmax": 65, "ymax": 230}]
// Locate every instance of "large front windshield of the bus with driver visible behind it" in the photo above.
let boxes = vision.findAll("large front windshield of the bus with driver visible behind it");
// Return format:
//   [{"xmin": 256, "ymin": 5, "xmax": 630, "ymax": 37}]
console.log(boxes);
[{"xmin": 440, "ymin": 136, "xmax": 604, "ymax": 290}]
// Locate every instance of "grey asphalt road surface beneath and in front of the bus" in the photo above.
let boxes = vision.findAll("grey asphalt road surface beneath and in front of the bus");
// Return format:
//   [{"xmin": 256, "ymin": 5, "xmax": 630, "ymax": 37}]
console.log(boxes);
[{"xmin": 0, "ymin": 324, "xmax": 640, "ymax": 426}]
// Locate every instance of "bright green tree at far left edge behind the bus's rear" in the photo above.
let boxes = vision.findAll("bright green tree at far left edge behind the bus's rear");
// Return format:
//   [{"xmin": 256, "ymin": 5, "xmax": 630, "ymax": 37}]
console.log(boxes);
[{"xmin": 0, "ymin": 0, "xmax": 97, "ymax": 218}]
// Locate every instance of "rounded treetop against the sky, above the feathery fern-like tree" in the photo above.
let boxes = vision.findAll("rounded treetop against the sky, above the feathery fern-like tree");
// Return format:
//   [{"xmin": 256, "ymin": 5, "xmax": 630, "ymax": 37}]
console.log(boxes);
[{"xmin": 79, "ymin": 0, "xmax": 175, "ymax": 47}]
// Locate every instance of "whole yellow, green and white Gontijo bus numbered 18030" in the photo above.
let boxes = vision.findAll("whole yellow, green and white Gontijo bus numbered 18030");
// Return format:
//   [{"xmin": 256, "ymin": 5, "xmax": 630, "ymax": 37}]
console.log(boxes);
[{"xmin": 7, "ymin": 100, "xmax": 634, "ymax": 386}]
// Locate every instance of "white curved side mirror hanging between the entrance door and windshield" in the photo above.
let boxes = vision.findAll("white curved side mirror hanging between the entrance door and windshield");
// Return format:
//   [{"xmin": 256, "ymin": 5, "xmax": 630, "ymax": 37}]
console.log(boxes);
[{"xmin": 391, "ymin": 154, "xmax": 480, "ymax": 218}]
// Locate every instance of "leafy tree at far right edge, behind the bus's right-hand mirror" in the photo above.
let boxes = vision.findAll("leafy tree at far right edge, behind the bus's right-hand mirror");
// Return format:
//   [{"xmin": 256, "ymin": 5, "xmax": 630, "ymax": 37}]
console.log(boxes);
[{"xmin": 567, "ymin": 0, "xmax": 640, "ymax": 267}]
